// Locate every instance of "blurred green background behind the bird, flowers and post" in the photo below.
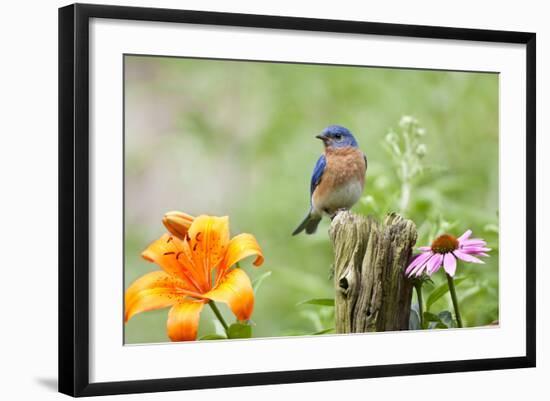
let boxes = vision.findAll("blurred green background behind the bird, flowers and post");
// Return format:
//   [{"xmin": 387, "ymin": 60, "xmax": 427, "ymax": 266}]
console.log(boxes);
[{"xmin": 124, "ymin": 56, "xmax": 499, "ymax": 343}]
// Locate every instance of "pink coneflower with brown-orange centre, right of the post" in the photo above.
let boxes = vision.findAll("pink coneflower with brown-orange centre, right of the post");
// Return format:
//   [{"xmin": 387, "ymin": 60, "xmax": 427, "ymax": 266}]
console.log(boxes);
[{"xmin": 405, "ymin": 230, "xmax": 491, "ymax": 277}]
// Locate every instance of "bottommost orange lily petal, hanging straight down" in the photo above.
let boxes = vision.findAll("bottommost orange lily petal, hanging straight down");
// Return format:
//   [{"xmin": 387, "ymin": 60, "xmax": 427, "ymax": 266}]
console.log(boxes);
[{"xmin": 166, "ymin": 299, "xmax": 205, "ymax": 341}]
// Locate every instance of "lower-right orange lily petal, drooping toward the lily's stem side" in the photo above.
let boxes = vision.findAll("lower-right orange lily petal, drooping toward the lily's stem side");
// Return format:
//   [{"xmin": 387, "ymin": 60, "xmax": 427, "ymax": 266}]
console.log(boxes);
[{"xmin": 204, "ymin": 269, "xmax": 254, "ymax": 320}]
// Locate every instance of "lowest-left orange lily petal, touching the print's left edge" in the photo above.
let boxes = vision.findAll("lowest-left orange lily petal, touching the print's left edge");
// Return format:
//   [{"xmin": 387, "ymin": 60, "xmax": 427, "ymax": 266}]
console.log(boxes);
[{"xmin": 124, "ymin": 271, "xmax": 190, "ymax": 322}]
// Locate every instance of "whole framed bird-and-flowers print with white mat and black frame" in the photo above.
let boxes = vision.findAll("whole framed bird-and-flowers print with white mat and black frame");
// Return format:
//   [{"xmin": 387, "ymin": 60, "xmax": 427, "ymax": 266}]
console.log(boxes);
[{"xmin": 59, "ymin": 4, "xmax": 536, "ymax": 396}]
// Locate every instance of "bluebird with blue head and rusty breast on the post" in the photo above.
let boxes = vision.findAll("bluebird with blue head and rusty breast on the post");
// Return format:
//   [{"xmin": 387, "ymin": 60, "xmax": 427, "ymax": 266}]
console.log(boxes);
[{"xmin": 292, "ymin": 125, "xmax": 367, "ymax": 235}]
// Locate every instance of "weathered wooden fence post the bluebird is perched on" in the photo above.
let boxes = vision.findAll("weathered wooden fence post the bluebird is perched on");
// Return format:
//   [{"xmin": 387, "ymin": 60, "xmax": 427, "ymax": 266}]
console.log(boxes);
[{"xmin": 329, "ymin": 211, "xmax": 417, "ymax": 333}]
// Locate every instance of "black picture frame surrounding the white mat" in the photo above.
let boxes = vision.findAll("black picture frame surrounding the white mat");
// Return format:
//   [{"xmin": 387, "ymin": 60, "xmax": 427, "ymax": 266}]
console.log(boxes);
[{"xmin": 59, "ymin": 4, "xmax": 536, "ymax": 396}]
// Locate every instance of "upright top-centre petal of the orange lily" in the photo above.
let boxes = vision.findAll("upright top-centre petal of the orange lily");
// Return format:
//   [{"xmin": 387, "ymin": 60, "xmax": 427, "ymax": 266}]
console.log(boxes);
[{"xmin": 187, "ymin": 215, "xmax": 229, "ymax": 283}]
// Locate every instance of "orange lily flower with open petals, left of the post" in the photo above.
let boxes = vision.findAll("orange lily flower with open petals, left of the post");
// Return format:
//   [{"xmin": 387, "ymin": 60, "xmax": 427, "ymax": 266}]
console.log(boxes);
[{"xmin": 124, "ymin": 212, "xmax": 264, "ymax": 341}]
